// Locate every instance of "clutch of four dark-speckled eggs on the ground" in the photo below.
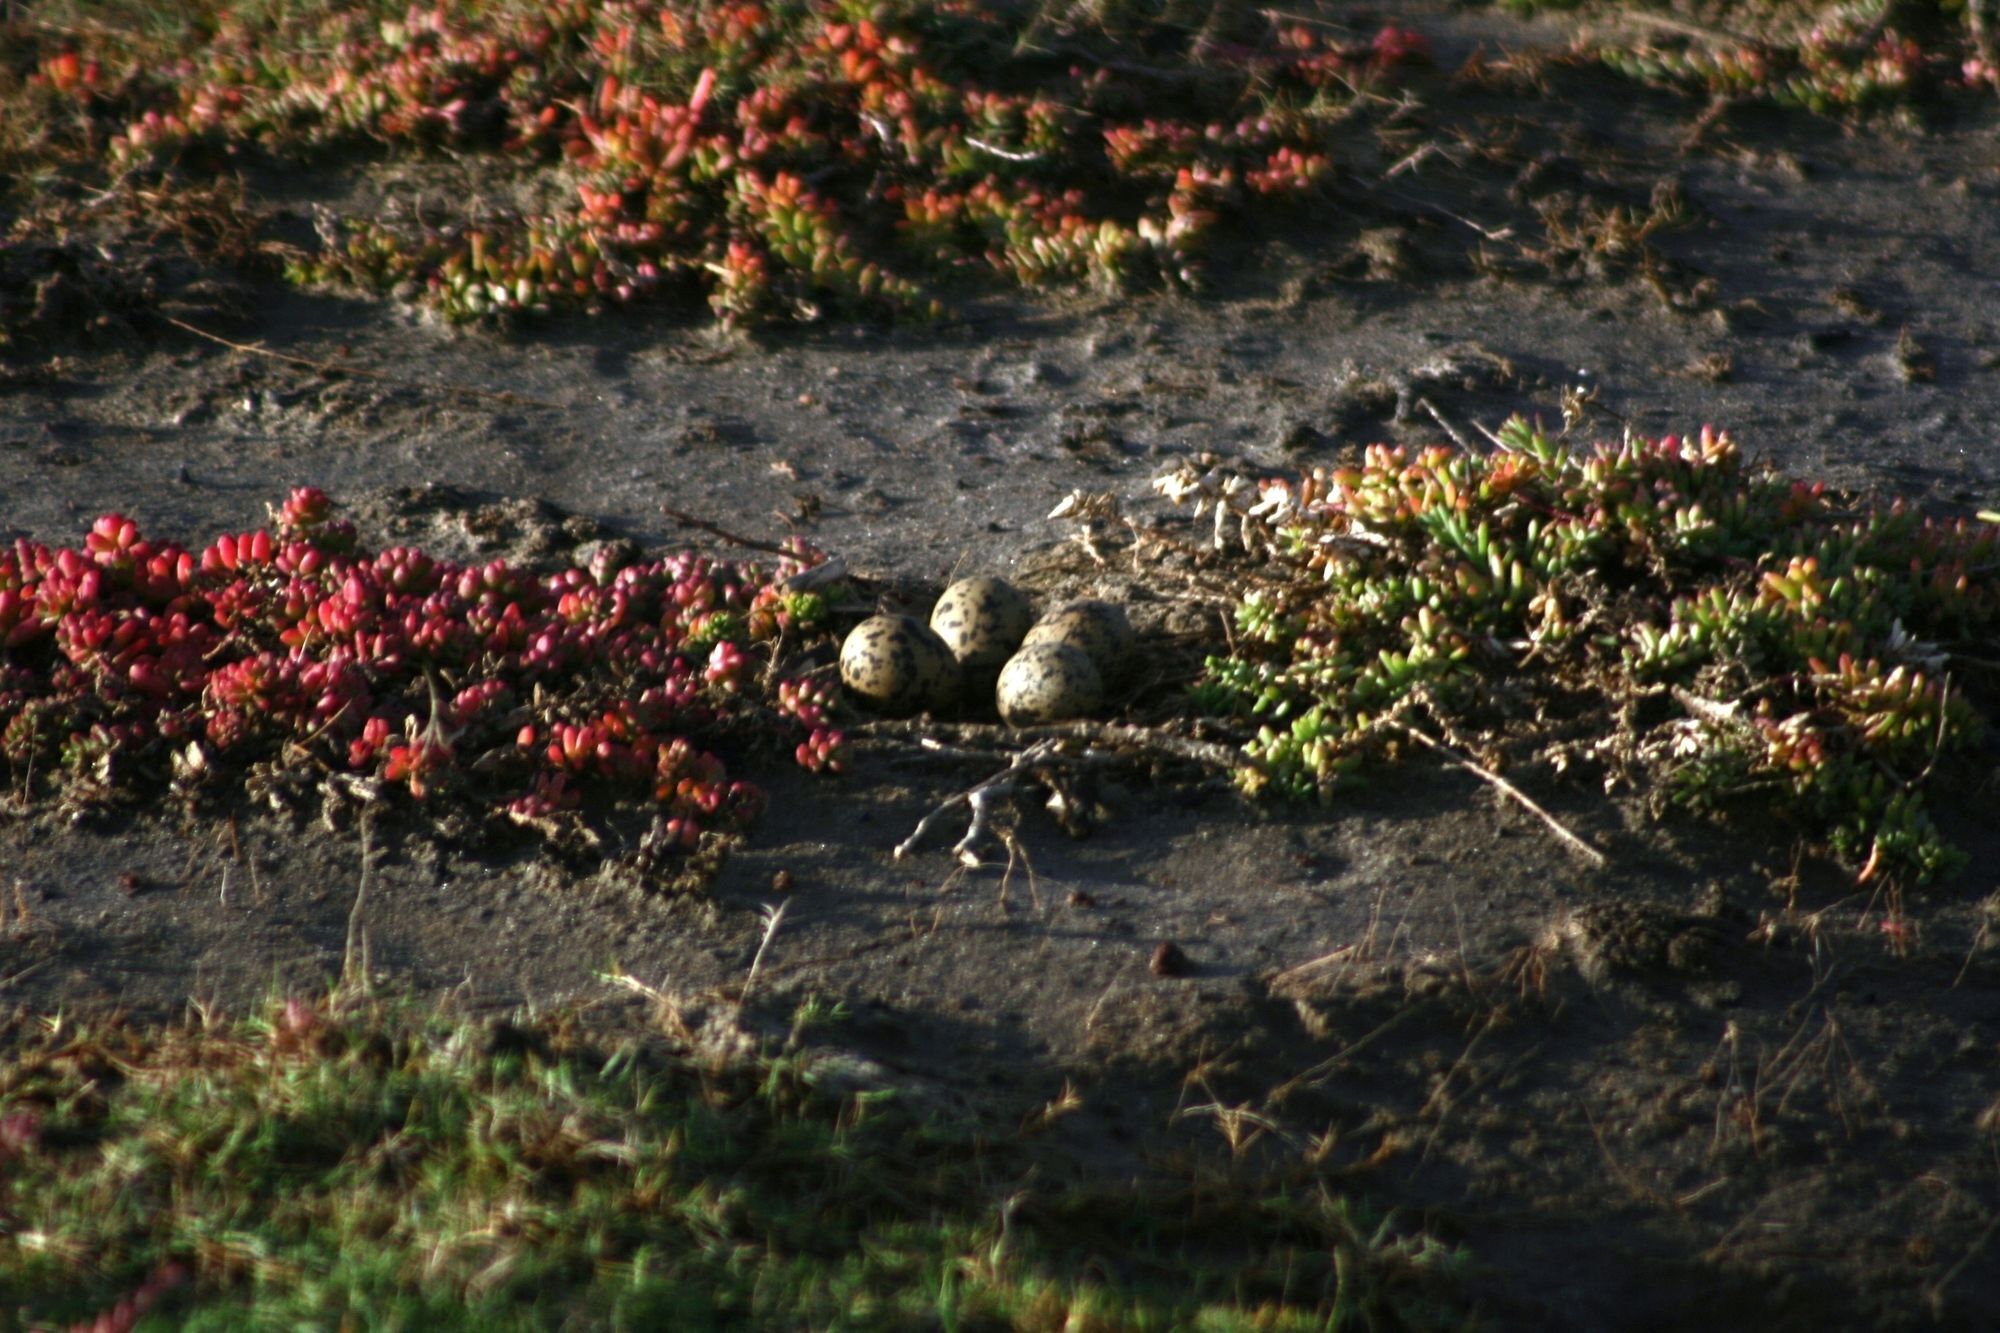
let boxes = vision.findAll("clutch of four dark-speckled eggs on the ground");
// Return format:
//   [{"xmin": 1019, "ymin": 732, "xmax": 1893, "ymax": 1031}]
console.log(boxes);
[{"xmin": 840, "ymin": 576, "xmax": 1134, "ymax": 727}]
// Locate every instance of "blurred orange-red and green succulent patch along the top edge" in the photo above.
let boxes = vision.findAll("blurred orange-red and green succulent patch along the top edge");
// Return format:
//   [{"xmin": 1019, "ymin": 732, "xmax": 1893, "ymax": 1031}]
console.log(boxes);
[{"xmin": 16, "ymin": 0, "xmax": 1424, "ymax": 322}]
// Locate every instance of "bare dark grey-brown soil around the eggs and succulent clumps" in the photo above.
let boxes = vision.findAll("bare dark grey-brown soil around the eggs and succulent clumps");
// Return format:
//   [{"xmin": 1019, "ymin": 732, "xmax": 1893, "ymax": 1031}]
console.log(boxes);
[{"xmin": 0, "ymin": 6, "xmax": 2000, "ymax": 1329}]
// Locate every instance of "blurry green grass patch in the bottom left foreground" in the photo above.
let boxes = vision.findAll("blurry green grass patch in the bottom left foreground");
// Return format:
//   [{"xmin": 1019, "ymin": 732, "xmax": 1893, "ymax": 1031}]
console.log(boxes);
[{"xmin": 0, "ymin": 999, "xmax": 1454, "ymax": 1329}]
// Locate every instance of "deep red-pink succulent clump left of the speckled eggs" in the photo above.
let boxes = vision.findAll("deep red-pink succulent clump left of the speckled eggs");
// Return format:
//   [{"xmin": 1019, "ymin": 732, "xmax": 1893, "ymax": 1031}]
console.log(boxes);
[{"xmin": 0, "ymin": 488, "xmax": 844, "ymax": 849}]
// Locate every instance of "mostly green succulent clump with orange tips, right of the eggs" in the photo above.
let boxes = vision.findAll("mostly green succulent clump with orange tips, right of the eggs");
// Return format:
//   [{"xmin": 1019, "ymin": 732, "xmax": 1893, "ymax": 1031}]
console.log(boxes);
[{"xmin": 1160, "ymin": 420, "xmax": 2000, "ymax": 881}]
